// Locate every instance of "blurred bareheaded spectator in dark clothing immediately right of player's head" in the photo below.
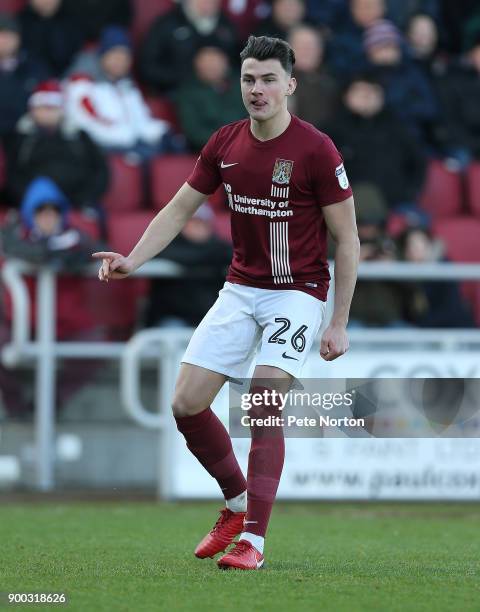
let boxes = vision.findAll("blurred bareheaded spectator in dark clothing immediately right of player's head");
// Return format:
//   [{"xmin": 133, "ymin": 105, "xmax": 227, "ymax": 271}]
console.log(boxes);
[{"xmin": 288, "ymin": 25, "xmax": 340, "ymax": 130}]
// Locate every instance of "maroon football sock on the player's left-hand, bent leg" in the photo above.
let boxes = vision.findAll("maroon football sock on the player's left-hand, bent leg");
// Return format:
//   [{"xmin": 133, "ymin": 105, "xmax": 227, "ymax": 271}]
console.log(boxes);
[{"xmin": 175, "ymin": 408, "xmax": 247, "ymax": 499}]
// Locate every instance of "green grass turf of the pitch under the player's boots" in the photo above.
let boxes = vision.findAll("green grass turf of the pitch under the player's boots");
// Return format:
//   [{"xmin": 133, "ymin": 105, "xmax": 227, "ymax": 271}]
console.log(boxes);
[{"xmin": 0, "ymin": 503, "xmax": 480, "ymax": 612}]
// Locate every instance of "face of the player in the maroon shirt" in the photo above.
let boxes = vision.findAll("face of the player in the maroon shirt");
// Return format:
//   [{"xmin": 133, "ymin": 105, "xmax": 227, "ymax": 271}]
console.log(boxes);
[{"xmin": 241, "ymin": 57, "xmax": 296, "ymax": 121}]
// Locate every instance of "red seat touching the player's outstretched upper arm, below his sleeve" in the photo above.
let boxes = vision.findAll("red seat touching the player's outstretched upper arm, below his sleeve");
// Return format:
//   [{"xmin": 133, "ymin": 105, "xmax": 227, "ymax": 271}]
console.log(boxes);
[{"xmin": 151, "ymin": 155, "xmax": 198, "ymax": 210}]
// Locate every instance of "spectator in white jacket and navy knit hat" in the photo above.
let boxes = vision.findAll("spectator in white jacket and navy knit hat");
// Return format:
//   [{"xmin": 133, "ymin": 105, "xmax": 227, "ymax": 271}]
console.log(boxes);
[{"xmin": 66, "ymin": 26, "xmax": 176, "ymax": 159}]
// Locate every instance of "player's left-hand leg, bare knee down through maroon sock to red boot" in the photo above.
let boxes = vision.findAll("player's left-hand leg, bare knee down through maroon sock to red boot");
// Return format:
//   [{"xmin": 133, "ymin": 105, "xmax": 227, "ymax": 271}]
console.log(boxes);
[{"xmin": 172, "ymin": 363, "xmax": 247, "ymax": 558}]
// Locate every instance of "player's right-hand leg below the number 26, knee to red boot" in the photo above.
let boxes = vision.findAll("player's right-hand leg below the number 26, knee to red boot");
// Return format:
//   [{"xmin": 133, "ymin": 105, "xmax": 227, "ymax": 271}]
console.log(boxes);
[{"xmin": 218, "ymin": 365, "xmax": 293, "ymax": 569}]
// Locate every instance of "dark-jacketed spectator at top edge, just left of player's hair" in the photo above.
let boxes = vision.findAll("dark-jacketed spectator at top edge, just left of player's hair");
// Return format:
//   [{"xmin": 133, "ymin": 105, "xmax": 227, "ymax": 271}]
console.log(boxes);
[{"xmin": 138, "ymin": 0, "xmax": 239, "ymax": 94}]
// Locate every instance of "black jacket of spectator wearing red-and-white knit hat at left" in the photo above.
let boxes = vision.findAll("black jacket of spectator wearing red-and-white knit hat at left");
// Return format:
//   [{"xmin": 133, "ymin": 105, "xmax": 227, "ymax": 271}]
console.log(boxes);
[{"xmin": 7, "ymin": 117, "xmax": 109, "ymax": 207}]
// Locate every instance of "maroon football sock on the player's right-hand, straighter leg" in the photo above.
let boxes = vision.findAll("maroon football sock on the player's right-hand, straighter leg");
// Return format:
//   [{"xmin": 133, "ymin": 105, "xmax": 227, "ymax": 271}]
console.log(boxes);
[{"xmin": 244, "ymin": 387, "xmax": 285, "ymax": 537}]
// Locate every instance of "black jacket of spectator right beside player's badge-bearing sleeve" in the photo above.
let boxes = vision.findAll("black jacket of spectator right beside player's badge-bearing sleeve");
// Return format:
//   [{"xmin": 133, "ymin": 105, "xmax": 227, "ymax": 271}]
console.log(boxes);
[{"xmin": 326, "ymin": 108, "xmax": 426, "ymax": 207}]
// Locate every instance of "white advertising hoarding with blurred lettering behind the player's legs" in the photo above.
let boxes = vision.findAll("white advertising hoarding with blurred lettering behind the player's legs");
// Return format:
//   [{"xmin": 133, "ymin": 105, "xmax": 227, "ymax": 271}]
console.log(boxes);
[{"xmin": 171, "ymin": 349, "xmax": 480, "ymax": 500}]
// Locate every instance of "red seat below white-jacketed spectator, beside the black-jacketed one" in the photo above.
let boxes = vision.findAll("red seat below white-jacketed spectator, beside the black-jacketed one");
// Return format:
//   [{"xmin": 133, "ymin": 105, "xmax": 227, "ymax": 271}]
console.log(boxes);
[{"xmin": 103, "ymin": 155, "xmax": 143, "ymax": 213}]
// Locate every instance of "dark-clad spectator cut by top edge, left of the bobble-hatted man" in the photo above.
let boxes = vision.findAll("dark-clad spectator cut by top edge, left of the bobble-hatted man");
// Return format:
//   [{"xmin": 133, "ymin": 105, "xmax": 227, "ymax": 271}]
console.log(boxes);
[{"xmin": 327, "ymin": 0, "xmax": 386, "ymax": 77}]
